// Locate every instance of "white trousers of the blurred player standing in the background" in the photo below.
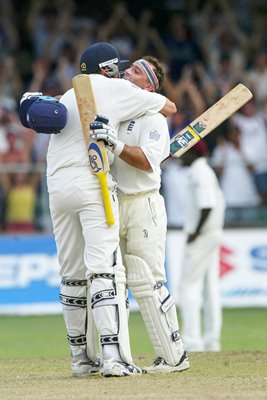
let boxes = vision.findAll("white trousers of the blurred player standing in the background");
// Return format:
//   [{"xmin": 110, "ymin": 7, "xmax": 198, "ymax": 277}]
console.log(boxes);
[{"xmin": 180, "ymin": 231, "xmax": 222, "ymax": 351}]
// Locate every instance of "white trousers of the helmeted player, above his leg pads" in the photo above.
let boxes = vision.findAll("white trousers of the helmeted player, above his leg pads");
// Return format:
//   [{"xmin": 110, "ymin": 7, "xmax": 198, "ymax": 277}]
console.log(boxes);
[{"xmin": 47, "ymin": 167, "xmax": 119, "ymax": 280}]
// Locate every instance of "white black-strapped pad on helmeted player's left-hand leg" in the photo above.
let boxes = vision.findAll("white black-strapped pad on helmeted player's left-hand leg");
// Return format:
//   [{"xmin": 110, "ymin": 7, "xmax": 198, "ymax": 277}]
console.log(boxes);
[{"xmin": 60, "ymin": 278, "xmax": 97, "ymax": 361}]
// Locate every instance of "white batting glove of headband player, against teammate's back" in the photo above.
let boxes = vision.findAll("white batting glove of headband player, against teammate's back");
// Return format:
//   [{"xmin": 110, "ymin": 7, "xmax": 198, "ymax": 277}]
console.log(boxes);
[{"xmin": 89, "ymin": 121, "xmax": 124, "ymax": 156}]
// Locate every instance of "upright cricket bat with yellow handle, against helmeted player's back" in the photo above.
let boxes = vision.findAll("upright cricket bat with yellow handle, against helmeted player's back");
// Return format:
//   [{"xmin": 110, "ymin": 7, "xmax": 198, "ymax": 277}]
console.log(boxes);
[{"xmin": 72, "ymin": 74, "xmax": 115, "ymax": 225}]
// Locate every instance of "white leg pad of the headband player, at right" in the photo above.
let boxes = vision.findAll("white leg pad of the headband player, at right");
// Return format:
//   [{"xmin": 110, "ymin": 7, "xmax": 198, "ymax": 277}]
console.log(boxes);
[{"xmin": 124, "ymin": 254, "xmax": 184, "ymax": 366}]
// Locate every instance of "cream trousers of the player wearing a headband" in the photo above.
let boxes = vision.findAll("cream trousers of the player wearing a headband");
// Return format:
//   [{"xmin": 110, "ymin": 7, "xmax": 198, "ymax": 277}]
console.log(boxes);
[{"xmin": 119, "ymin": 191, "xmax": 167, "ymax": 282}]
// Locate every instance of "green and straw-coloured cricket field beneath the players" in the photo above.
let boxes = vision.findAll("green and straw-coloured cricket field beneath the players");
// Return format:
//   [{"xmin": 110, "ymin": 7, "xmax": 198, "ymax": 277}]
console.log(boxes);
[{"xmin": 0, "ymin": 308, "xmax": 267, "ymax": 400}]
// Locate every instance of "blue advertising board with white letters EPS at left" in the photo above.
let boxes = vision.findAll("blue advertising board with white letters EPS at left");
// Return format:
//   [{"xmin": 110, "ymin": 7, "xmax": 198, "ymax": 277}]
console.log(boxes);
[{"xmin": 0, "ymin": 235, "xmax": 61, "ymax": 314}]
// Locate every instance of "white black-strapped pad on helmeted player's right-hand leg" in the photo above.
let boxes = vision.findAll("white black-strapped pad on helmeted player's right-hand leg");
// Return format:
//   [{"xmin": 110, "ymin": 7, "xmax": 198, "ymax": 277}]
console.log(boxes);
[{"xmin": 91, "ymin": 265, "xmax": 133, "ymax": 364}]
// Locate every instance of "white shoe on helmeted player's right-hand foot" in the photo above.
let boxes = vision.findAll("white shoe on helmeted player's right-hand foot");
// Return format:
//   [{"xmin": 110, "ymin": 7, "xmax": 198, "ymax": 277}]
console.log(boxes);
[{"xmin": 100, "ymin": 358, "xmax": 142, "ymax": 378}]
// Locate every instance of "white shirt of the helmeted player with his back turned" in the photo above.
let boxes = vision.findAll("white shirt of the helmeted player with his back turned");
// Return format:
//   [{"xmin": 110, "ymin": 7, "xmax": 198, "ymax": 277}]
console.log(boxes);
[{"xmin": 47, "ymin": 74, "xmax": 166, "ymax": 176}]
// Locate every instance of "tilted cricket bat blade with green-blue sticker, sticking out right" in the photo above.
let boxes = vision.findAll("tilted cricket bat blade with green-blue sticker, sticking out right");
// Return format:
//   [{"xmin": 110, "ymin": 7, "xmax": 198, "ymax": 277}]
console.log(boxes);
[{"xmin": 170, "ymin": 83, "xmax": 253, "ymax": 158}]
